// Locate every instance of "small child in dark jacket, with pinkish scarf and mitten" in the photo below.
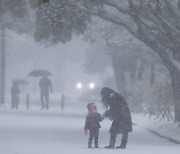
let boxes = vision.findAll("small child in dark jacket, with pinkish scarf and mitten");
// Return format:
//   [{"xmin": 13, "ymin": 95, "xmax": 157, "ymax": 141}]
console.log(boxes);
[{"xmin": 84, "ymin": 103, "xmax": 104, "ymax": 148}]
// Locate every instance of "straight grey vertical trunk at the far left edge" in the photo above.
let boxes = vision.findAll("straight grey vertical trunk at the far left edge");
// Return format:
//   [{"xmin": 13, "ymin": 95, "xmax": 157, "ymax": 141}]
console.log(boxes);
[{"xmin": 0, "ymin": 27, "xmax": 6, "ymax": 104}]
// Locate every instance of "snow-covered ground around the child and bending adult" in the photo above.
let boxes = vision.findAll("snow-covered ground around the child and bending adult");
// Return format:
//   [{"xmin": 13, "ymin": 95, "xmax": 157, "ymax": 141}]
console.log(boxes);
[{"xmin": 0, "ymin": 102, "xmax": 180, "ymax": 154}]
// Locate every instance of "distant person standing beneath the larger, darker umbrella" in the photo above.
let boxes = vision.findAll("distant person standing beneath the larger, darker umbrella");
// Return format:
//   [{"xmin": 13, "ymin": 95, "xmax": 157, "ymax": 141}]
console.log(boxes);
[{"xmin": 39, "ymin": 76, "xmax": 52, "ymax": 110}]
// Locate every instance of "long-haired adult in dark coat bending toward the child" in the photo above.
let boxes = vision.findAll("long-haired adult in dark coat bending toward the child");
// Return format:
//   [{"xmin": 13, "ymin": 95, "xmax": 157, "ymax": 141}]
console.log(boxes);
[{"xmin": 101, "ymin": 87, "xmax": 132, "ymax": 149}]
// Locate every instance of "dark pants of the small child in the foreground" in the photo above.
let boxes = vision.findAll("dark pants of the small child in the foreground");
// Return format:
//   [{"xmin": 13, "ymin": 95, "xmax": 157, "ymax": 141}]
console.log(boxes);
[{"xmin": 88, "ymin": 128, "xmax": 99, "ymax": 147}]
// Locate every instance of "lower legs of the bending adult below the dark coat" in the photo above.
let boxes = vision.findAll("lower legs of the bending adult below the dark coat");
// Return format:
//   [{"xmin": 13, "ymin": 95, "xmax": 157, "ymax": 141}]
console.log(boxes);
[{"xmin": 109, "ymin": 132, "xmax": 128, "ymax": 147}]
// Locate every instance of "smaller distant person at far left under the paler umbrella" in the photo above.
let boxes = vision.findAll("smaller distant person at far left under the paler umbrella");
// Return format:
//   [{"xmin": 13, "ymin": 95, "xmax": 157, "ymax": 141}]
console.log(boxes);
[{"xmin": 11, "ymin": 82, "xmax": 20, "ymax": 109}]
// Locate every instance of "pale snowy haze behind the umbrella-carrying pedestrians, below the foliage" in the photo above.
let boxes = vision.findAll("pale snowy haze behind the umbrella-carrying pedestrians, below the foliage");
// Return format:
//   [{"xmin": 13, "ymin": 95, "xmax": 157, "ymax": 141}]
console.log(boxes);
[{"xmin": 6, "ymin": 30, "xmax": 109, "ymax": 103}]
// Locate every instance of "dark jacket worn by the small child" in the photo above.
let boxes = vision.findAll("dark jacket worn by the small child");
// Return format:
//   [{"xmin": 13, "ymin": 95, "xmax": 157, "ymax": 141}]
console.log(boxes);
[{"xmin": 84, "ymin": 112, "xmax": 103, "ymax": 130}]
